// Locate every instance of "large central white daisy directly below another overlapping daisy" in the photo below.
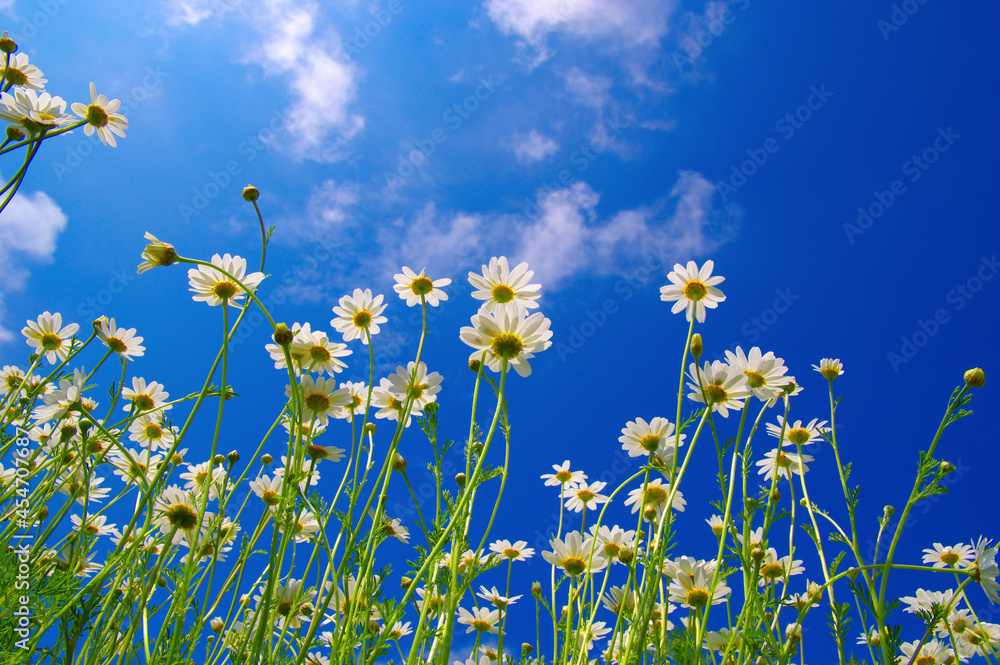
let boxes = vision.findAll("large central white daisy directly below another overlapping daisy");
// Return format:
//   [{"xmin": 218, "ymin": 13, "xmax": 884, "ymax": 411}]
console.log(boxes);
[{"xmin": 459, "ymin": 307, "xmax": 552, "ymax": 376}]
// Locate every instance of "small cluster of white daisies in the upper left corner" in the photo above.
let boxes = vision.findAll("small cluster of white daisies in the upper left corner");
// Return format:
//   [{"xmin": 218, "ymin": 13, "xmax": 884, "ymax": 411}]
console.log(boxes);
[{"xmin": 0, "ymin": 39, "xmax": 128, "ymax": 147}]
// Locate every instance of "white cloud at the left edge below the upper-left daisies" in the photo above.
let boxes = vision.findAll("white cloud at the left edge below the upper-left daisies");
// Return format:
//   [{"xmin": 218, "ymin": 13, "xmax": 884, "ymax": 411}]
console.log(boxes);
[{"xmin": 0, "ymin": 187, "xmax": 66, "ymax": 342}]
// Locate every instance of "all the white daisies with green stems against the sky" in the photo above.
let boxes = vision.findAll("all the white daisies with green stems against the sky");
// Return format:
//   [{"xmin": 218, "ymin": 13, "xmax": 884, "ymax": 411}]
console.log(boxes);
[{"xmin": 0, "ymin": 34, "xmax": 1000, "ymax": 665}]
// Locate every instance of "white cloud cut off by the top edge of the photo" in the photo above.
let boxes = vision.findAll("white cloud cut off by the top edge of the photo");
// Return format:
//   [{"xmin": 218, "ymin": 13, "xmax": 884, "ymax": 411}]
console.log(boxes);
[{"xmin": 486, "ymin": 0, "xmax": 677, "ymax": 47}]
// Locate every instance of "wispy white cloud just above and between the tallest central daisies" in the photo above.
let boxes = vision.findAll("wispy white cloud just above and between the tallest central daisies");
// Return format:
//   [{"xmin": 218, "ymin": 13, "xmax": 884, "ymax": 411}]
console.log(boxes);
[{"xmin": 514, "ymin": 171, "xmax": 740, "ymax": 288}]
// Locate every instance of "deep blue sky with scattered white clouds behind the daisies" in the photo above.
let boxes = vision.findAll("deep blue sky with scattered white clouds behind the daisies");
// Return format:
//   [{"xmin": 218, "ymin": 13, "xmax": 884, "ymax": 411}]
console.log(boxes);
[{"xmin": 0, "ymin": 0, "xmax": 1000, "ymax": 652}]
